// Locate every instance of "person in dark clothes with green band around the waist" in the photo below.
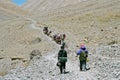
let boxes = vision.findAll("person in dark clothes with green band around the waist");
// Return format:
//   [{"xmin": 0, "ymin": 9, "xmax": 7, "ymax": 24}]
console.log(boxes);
[{"xmin": 58, "ymin": 46, "xmax": 67, "ymax": 74}]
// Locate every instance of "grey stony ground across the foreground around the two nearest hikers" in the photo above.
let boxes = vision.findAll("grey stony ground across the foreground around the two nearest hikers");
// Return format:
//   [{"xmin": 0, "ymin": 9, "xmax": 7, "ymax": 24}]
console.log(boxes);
[{"xmin": 1, "ymin": 42, "xmax": 120, "ymax": 80}]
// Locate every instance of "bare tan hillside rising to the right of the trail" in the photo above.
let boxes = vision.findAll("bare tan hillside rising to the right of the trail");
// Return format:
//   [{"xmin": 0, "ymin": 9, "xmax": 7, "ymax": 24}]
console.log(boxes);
[{"xmin": 31, "ymin": 0, "xmax": 120, "ymax": 46}]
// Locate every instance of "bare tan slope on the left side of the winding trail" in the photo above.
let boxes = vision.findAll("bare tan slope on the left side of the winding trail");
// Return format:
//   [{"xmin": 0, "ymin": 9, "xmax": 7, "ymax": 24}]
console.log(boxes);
[{"xmin": 0, "ymin": 0, "xmax": 57, "ymax": 75}]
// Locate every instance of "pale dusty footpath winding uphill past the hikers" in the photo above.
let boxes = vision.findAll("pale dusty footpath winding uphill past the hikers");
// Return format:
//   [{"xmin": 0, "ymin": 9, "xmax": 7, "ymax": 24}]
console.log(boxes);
[{"xmin": 26, "ymin": 19, "xmax": 96, "ymax": 80}]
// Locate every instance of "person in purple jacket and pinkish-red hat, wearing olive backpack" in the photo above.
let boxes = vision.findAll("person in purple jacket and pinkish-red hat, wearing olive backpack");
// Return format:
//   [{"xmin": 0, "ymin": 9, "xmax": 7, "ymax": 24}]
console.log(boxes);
[{"xmin": 77, "ymin": 45, "xmax": 88, "ymax": 71}]
